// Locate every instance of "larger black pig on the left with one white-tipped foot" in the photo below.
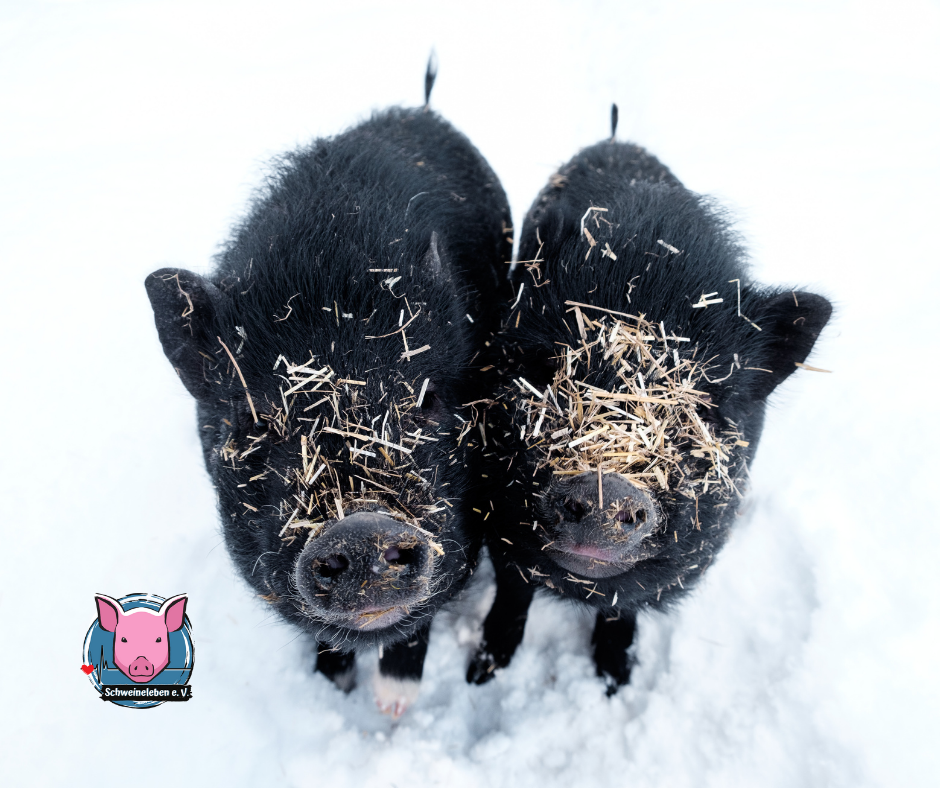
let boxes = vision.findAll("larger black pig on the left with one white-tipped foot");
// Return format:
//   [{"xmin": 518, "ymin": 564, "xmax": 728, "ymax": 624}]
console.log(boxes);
[{"xmin": 146, "ymin": 66, "xmax": 512, "ymax": 716}]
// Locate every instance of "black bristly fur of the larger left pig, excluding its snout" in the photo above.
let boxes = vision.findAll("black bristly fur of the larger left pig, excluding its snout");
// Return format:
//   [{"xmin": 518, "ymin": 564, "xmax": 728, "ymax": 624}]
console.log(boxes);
[{"xmin": 146, "ymin": 71, "xmax": 511, "ymax": 692}]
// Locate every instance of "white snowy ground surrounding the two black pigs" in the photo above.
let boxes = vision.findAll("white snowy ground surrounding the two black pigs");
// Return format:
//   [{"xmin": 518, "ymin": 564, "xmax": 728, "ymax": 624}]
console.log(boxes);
[{"xmin": 0, "ymin": 0, "xmax": 940, "ymax": 788}]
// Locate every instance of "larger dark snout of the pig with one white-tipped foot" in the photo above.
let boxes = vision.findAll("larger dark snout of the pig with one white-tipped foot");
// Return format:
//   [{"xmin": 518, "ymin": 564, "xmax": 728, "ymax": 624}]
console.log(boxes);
[{"xmin": 294, "ymin": 512, "xmax": 432, "ymax": 631}]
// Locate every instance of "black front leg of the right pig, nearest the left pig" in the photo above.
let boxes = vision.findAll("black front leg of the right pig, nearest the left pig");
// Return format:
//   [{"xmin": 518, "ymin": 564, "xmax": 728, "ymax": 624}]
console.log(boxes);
[{"xmin": 467, "ymin": 559, "xmax": 535, "ymax": 684}]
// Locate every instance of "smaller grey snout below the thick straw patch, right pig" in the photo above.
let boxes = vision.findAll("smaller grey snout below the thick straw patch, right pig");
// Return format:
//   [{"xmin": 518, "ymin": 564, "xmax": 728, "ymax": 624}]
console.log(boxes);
[{"xmin": 546, "ymin": 472, "xmax": 659, "ymax": 578}]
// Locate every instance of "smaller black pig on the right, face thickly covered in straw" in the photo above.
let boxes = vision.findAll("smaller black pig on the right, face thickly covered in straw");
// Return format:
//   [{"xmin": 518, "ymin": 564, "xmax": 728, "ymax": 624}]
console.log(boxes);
[{"xmin": 467, "ymin": 107, "xmax": 831, "ymax": 693}]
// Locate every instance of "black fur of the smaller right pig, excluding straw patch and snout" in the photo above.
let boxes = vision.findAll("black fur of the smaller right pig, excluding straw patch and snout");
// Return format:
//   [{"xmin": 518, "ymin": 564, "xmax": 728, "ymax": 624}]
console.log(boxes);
[{"xmin": 467, "ymin": 121, "xmax": 831, "ymax": 690}]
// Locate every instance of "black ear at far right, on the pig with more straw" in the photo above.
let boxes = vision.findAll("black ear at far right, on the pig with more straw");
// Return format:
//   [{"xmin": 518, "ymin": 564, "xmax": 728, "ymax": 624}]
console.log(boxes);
[{"xmin": 750, "ymin": 291, "xmax": 832, "ymax": 400}]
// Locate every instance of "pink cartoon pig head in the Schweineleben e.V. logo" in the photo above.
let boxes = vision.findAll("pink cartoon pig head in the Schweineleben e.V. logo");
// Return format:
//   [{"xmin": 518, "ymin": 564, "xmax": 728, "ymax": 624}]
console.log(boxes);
[{"xmin": 95, "ymin": 594, "xmax": 186, "ymax": 684}]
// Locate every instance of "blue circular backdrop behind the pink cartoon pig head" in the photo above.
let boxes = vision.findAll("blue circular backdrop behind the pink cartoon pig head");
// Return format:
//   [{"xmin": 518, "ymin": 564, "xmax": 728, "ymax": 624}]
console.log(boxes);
[{"xmin": 82, "ymin": 594, "xmax": 195, "ymax": 709}]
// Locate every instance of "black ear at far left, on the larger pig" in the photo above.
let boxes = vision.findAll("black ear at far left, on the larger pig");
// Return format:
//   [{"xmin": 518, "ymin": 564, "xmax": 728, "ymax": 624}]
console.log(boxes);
[{"xmin": 144, "ymin": 268, "xmax": 220, "ymax": 401}]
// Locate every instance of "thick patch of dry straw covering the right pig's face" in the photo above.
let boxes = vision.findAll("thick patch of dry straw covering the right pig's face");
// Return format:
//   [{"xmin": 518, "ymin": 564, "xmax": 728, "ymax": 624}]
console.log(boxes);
[{"xmin": 512, "ymin": 308, "xmax": 747, "ymax": 498}]
